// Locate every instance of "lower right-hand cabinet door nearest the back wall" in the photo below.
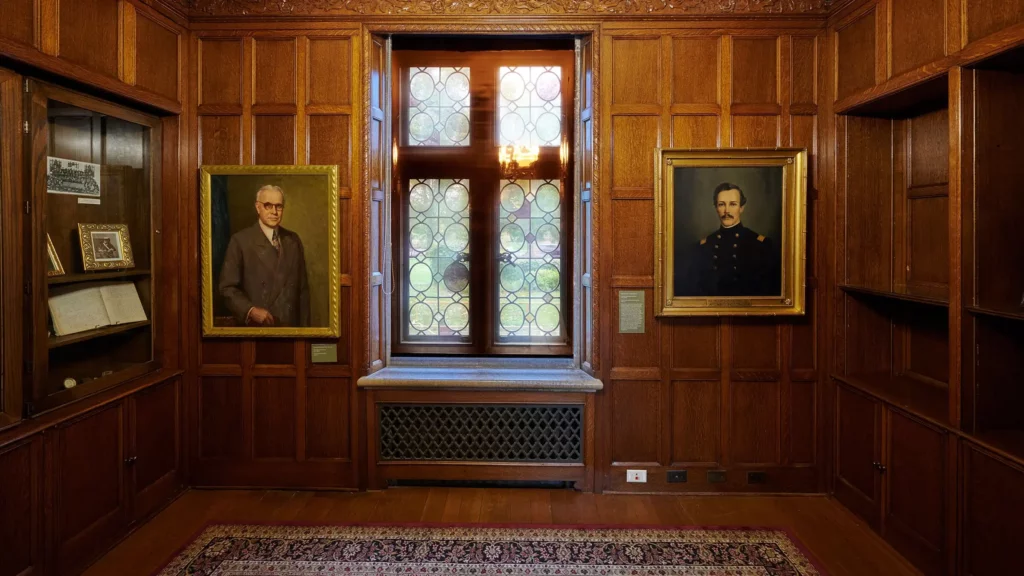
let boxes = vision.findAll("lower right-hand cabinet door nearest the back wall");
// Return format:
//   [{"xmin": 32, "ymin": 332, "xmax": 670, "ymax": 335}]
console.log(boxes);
[{"xmin": 836, "ymin": 385, "xmax": 882, "ymax": 530}]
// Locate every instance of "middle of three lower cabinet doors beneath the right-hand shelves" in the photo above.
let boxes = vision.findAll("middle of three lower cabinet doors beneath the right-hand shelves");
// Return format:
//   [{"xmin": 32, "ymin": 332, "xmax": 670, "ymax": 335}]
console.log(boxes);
[{"xmin": 883, "ymin": 411, "xmax": 950, "ymax": 575}]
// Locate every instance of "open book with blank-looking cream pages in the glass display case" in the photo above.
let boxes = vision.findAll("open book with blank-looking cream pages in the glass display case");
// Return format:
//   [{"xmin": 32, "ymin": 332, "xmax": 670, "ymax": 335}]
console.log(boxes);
[{"xmin": 48, "ymin": 282, "xmax": 148, "ymax": 336}]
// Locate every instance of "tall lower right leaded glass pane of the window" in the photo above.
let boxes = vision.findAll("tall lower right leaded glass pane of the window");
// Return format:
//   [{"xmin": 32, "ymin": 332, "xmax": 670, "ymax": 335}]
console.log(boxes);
[{"xmin": 498, "ymin": 180, "xmax": 568, "ymax": 343}]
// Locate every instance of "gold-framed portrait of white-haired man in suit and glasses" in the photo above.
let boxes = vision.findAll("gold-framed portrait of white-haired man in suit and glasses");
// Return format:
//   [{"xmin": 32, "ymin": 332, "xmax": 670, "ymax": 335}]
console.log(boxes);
[{"xmin": 202, "ymin": 166, "xmax": 340, "ymax": 336}]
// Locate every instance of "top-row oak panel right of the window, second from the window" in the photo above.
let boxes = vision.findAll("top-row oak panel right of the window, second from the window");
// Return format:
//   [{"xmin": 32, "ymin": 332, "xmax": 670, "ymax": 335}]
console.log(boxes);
[{"xmin": 672, "ymin": 36, "xmax": 722, "ymax": 104}]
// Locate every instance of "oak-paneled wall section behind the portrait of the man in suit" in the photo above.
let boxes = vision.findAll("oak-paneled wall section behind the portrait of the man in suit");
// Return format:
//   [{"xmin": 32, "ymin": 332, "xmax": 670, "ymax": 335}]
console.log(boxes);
[{"xmin": 189, "ymin": 26, "xmax": 366, "ymax": 488}]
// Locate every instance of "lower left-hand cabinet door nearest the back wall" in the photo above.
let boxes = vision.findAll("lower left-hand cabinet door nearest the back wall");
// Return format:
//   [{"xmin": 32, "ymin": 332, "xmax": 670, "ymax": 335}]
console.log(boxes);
[{"xmin": 128, "ymin": 378, "xmax": 181, "ymax": 522}]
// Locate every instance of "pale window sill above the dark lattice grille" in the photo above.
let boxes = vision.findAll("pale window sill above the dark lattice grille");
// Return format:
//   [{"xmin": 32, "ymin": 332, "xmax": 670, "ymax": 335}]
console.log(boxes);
[{"xmin": 356, "ymin": 358, "xmax": 604, "ymax": 393}]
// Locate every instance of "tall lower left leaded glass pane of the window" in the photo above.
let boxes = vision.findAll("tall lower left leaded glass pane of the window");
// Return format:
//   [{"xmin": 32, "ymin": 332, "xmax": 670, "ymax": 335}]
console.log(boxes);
[{"xmin": 406, "ymin": 179, "xmax": 470, "ymax": 341}]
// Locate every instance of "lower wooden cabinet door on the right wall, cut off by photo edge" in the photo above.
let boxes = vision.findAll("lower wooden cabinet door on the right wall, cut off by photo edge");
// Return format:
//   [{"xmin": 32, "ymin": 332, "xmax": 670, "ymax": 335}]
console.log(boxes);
[{"xmin": 962, "ymin": 444, "xmax": 1024, "ymax": 576}]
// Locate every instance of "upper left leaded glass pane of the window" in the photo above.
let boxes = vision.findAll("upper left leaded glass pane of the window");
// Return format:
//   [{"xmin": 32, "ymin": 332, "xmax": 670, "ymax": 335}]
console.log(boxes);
[{"xmin": 407, "ymin": 67, "xmax": 469, "ymax": 146}]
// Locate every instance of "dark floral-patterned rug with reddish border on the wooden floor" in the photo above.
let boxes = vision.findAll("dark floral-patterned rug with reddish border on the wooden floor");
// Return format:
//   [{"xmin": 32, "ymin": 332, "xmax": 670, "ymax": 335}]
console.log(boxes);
[{"xmin": 153, "ymin": 525, "xmax": 823, "ymax": 576}]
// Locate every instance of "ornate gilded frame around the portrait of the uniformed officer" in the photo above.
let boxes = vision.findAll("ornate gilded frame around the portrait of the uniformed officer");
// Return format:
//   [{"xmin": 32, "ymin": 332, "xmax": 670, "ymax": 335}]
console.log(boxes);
[{"xmin": 654, "ymin": 149, "xmax": 807, "ymax": 317}]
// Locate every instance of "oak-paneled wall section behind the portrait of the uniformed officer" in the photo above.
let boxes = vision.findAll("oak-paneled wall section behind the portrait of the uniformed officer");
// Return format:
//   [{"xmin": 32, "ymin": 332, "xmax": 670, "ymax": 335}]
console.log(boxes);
[{"xmin": 598, "ymin": 22, "xmax": 825, "ymax": 491}]
